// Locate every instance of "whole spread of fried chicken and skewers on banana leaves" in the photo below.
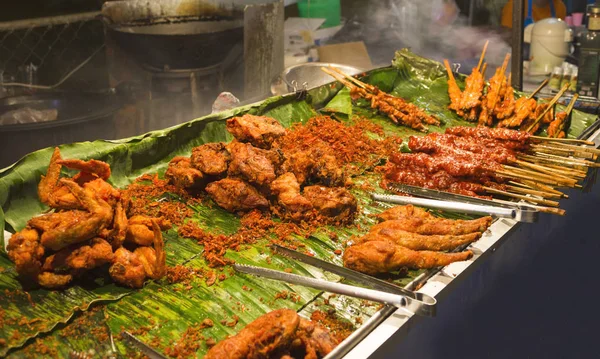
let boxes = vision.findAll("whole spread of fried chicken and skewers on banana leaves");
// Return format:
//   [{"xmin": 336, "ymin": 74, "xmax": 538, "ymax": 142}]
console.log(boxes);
[{"xmin": 0, "ymin": 51, "xmax": 598, "ymax": 358}]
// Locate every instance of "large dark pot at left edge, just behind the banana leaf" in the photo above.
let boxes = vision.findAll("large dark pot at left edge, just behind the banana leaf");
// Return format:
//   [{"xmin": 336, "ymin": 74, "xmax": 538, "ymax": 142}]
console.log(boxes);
[{"xmin": 0, "ymin": 93, "xmax": 121, "ymax": 168}]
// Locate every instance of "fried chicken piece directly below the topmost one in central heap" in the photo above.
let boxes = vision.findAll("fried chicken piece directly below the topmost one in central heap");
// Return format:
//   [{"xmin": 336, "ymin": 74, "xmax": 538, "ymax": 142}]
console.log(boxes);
[{"xmin": 228, "ymin": 142, "xmax": 276, "ymax": 187}]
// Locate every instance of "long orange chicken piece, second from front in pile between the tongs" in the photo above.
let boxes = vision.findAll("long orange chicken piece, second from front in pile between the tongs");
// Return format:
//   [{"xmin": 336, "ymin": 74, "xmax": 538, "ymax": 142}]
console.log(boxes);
[{"xmin": 356, "ymin": 228, "xmax": 481, "ymax": 251}]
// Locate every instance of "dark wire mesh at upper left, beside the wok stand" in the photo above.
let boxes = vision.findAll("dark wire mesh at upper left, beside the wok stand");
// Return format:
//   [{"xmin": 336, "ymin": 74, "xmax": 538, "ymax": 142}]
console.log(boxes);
[{"xmin": 0, "ymin": 12, "xmax": 108, "ymax": 92}]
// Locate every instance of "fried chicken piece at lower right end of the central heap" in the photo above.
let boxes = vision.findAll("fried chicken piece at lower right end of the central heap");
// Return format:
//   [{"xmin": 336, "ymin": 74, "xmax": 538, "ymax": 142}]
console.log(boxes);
[{"xmin": 304, "ymin": 186, "xmax": 358, "ymax": 221}]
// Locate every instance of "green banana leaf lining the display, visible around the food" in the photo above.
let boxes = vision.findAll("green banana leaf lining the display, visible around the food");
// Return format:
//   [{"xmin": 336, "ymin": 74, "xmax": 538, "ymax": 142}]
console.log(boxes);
[{"xmin": 0, "ymin": 51, "xmax": 596, "ymax": 357}]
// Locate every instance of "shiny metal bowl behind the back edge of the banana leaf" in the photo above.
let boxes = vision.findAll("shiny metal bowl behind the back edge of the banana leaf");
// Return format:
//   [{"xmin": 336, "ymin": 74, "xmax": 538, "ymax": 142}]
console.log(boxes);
[{"xmin": 271, "ymin": 62, "xmax": 365, "ymax": 95}]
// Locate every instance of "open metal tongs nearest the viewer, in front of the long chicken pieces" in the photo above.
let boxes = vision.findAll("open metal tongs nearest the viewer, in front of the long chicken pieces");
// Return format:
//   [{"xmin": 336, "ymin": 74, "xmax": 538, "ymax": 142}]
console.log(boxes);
[{"xmin": 233, "ymin": 244, "xmax": 436, "ymax": 317}]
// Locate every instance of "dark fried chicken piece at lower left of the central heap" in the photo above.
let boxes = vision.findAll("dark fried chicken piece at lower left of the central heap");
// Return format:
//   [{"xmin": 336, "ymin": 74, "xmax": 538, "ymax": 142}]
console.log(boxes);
[{"xmin": 206, "ymin": 178, "xmax": 269, "ymax": 212}]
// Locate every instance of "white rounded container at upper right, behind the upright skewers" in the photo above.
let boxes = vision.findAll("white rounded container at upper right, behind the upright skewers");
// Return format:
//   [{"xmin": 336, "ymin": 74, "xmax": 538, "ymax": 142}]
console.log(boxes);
[{"xmin": 525, "ymin": 18, "xmax": 573, "ymax": 74}]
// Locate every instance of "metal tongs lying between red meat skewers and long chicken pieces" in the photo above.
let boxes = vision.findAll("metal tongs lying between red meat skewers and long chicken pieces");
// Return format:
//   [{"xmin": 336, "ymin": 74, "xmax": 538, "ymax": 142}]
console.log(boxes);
[{"xmin": 371, "ymin": 183, "xmax": 539, "ymax": 223}]
